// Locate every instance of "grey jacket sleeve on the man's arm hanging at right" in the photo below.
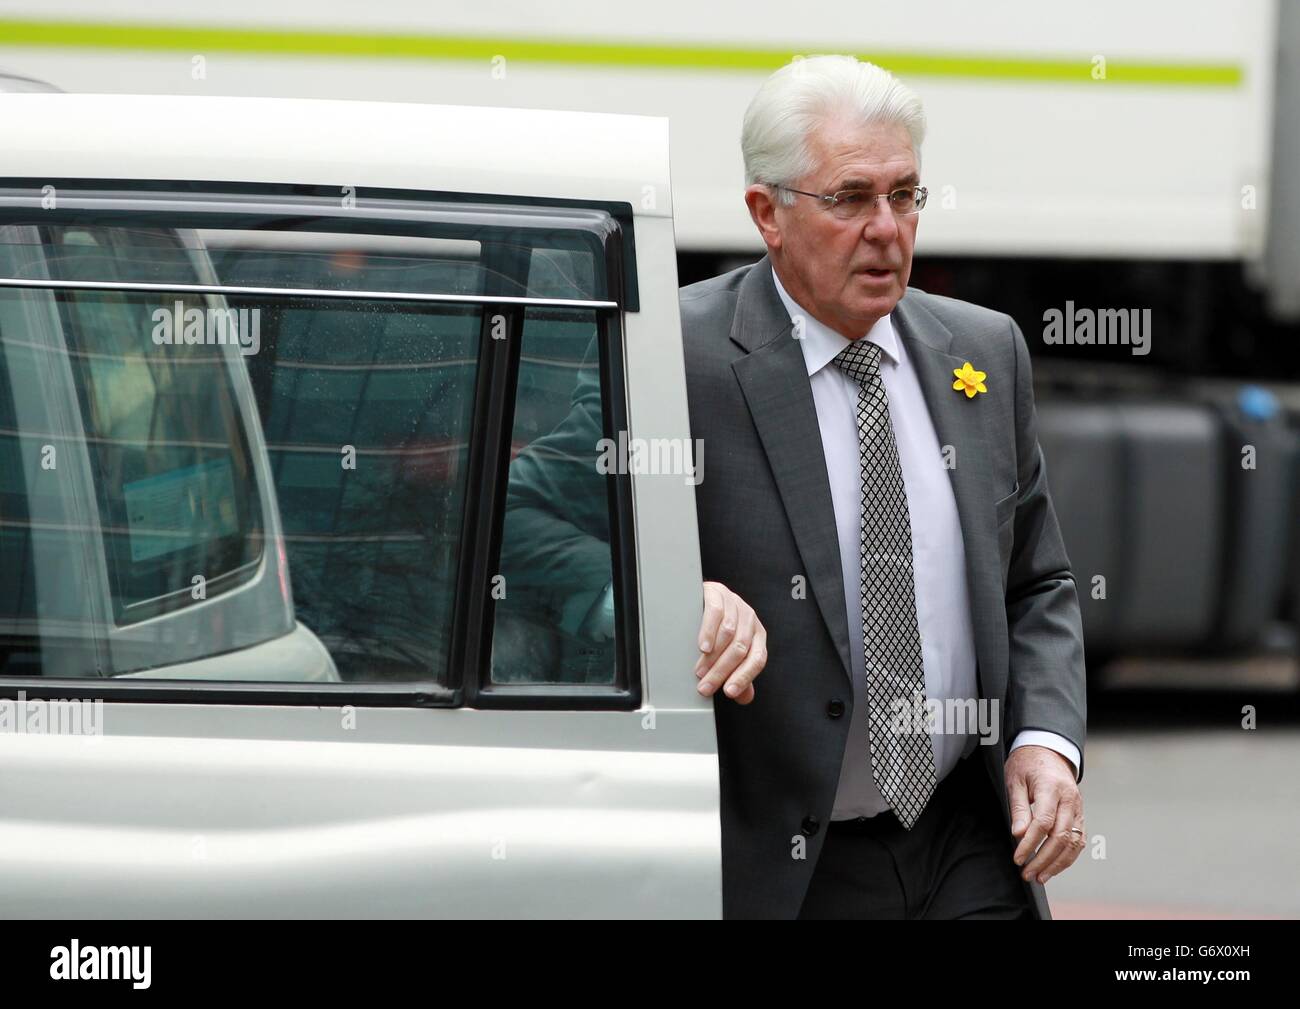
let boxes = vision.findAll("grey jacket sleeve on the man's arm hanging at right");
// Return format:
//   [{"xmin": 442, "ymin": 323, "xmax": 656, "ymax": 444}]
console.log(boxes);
[{"xmin": 1006, "ymin": 320, "xmax": 1087, "ymax": 780}]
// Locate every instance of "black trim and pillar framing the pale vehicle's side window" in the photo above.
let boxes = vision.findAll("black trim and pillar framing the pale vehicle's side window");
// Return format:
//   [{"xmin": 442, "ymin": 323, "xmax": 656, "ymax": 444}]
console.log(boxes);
[{"xmin": 0, "ymin": 178, "xmax": 642, "ymax": 711}]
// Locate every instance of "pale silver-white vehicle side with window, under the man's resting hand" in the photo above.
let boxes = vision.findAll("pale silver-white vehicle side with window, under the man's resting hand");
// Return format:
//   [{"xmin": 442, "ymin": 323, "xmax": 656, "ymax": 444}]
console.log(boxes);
[{"xmin": 0, "ymin": 94, "xmax": 722, "ymax": 918}]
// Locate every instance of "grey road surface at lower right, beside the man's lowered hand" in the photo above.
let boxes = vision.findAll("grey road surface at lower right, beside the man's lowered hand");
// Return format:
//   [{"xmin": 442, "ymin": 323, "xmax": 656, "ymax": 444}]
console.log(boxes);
[{"xmin": 1048, "ymin": 692, "xmax": 1300, "ymax": 919}]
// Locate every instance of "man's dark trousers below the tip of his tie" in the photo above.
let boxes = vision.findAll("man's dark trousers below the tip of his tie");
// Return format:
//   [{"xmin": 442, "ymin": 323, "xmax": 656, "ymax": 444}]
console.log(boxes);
[{"xmin": 800, "ymin": 752, "xmax": 1034, "ymax": 919}]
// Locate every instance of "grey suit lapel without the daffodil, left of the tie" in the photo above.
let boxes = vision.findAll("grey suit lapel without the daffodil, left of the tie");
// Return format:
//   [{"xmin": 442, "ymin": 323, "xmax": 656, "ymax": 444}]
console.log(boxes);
[{"xmin": 731, "ymin": 256, "xmax": 852, "ymax": 679}]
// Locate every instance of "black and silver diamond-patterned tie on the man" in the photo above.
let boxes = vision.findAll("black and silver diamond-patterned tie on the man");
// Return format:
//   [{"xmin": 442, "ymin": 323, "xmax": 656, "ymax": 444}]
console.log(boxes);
[{"xmin": 835, "ymin": 337, "xmax": 939, "ymax": 830}]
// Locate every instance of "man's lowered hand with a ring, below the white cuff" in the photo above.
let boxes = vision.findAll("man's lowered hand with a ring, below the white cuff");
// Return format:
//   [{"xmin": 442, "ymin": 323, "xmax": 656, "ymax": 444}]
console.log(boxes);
[{"xmin": 1006, "ymin": 745, "xmax": 1088, "ymax": 883}]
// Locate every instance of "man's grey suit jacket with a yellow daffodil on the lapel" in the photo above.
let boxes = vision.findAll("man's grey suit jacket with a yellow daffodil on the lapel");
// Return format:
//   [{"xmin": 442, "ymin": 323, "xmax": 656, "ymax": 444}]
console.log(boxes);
[{"xmin": 680, "ymin": 256, "xmax": 1086, "ymax": 918}]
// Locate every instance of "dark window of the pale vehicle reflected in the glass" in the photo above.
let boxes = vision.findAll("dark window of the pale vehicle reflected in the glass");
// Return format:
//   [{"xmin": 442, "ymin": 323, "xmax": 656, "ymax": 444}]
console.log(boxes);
[{"xmin": 49, "ymin": 230, "xmax": 263, "ymax": 623}]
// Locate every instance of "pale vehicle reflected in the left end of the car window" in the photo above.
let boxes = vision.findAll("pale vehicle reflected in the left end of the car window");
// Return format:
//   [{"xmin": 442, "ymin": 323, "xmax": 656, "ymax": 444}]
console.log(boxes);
[{"xmin": 0, "ymin": 226, "xmax": 289, "ymax": 679}]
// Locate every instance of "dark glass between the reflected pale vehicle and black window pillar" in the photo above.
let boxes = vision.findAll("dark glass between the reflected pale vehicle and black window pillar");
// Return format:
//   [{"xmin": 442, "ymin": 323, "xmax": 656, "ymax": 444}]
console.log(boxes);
[{"xmin": 231, "ymin": 296, "xmax": 481, "ymax": 683}]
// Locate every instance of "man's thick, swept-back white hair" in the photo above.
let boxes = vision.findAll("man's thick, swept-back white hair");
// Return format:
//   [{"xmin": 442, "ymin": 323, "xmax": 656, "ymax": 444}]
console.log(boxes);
[{"xmin": 740, "ymin": 56, "xmax": 926, "ymax": 205}]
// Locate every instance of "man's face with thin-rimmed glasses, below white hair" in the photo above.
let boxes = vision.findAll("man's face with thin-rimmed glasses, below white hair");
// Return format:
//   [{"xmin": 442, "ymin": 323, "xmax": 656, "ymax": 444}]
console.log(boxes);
[{"xmin": 746, "ymin": 118, "xmax": 920, "ymax": 339}]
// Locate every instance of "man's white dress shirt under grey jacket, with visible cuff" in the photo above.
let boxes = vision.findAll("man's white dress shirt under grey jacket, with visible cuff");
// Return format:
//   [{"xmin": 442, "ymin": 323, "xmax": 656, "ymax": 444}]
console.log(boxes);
[{"xmin": 772, "ymin": 269, "xmax": 1079, "ymax": 819}]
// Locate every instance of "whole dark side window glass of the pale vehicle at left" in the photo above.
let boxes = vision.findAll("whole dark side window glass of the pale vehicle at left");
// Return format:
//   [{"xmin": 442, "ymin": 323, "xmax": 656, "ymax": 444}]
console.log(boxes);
[{"xmin": 0, "ymin": 189, "xmax": 628, "ymax": 706}]
